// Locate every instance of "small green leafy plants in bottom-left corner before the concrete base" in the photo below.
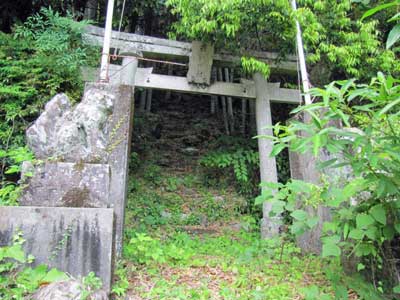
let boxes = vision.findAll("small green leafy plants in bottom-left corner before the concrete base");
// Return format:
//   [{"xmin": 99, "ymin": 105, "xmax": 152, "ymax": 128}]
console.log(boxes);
[{"xmin": 0, "ymin": 233, "xmax": 69, "ymax": 300}]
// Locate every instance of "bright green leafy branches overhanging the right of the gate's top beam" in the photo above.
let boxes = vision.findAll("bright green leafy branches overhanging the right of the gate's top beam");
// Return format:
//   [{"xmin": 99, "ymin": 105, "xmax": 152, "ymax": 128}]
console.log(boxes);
[{"xmin": 167, "ymin": 0, "xmax": 400, "ymax": 78}]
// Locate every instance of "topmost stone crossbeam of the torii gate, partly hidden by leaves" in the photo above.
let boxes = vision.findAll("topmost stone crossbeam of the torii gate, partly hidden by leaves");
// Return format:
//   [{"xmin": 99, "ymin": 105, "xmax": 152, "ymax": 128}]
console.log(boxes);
[{"xmin": 85, "ymin": 25, "xmax": 297, "ymax": 73}]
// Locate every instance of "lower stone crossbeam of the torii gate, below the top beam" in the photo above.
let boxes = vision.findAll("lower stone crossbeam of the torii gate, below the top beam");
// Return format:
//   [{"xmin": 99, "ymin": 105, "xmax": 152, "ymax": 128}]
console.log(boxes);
[{"xmin": 82, "ymin": 64, "xmax": 301, "ymax": 104}]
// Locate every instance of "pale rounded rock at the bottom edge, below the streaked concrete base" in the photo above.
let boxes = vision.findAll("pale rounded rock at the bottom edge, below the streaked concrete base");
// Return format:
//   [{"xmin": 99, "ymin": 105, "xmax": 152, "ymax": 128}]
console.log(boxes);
[{"xmin": 29, "ymin": 280, "xmax": 109, "ymax": 300}]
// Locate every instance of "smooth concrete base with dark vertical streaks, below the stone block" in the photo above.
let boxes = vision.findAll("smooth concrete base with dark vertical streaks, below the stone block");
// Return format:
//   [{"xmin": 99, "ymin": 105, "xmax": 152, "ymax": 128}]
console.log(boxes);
[{"xmin": 0, "ymin": 206, "xmax": 114, "ymax": 291}]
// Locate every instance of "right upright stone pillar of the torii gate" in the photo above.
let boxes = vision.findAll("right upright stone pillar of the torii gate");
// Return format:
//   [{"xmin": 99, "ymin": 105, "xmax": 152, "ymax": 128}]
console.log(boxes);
[{"xmin": 254, "ymin": 73, "xmax": 281, "ymax": 238}]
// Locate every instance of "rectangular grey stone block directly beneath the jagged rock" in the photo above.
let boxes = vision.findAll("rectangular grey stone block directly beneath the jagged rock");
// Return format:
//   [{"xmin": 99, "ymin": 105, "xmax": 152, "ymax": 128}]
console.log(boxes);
[{"xmin": 19, "ymin": 162, "xmax": 113, "ymax": 208}]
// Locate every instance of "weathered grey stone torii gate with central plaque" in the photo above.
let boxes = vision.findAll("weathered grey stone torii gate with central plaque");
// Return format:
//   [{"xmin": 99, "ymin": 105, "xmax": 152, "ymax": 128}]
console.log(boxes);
[{"xmin": 84, "ymin": 26, "xmax": 301, "ymax": 237}]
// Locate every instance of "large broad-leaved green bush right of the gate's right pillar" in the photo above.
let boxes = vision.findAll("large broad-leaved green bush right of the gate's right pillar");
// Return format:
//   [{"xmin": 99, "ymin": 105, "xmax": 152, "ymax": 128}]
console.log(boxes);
[{"xmin": 258, "ymin": 73, "xmax": 400, "ymax": 292}]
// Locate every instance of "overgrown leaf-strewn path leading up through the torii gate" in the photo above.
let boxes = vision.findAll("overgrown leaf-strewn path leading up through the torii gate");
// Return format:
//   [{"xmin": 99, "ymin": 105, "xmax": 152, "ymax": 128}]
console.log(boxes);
[{"xmin": 113, "ymin": 92, "xmax": 379, "ymax": 300}]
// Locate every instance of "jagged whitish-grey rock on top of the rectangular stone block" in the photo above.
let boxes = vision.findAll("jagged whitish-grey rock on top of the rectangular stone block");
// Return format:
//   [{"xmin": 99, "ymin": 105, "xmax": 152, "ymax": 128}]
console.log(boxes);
[{"xmin": 26, "ymin": 88, "xmax": 114, "ymax": 162}]
